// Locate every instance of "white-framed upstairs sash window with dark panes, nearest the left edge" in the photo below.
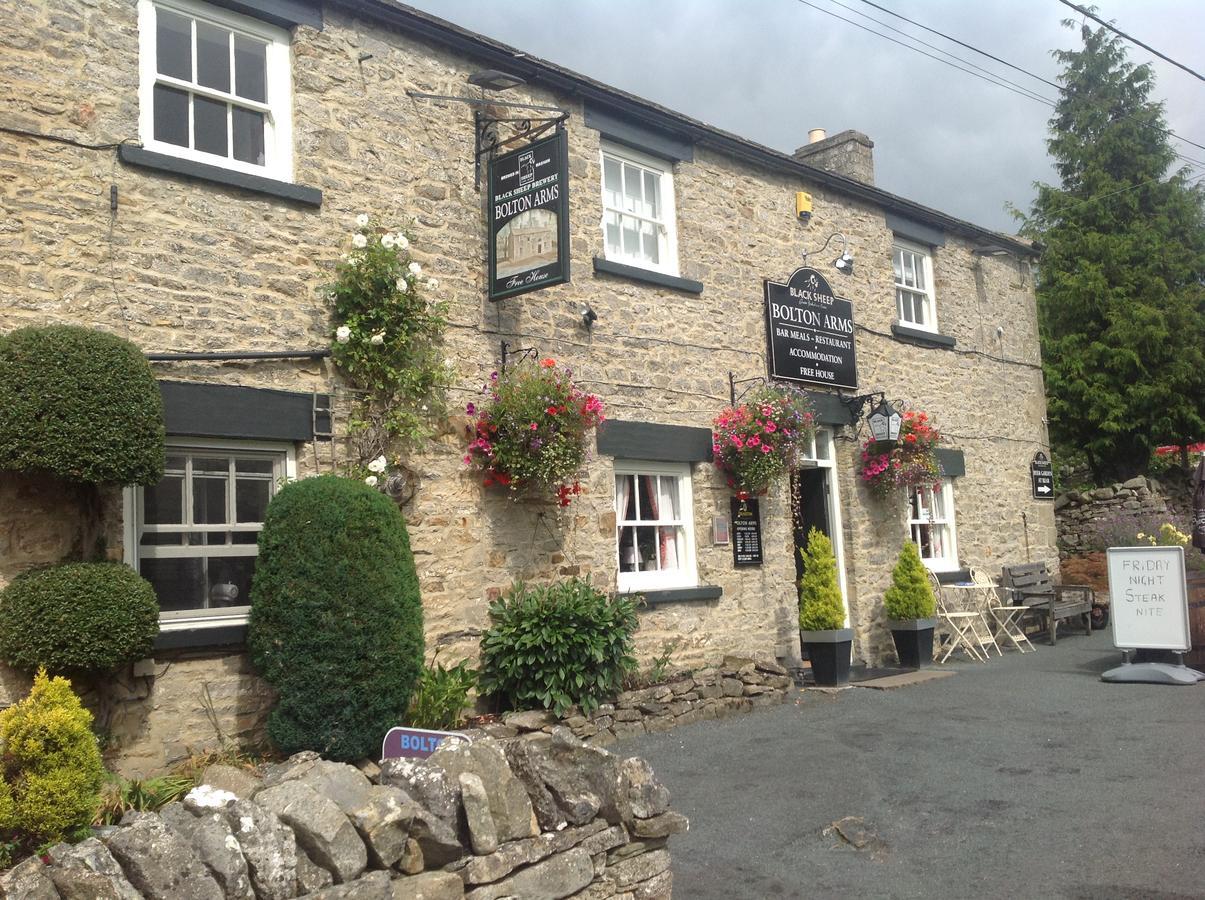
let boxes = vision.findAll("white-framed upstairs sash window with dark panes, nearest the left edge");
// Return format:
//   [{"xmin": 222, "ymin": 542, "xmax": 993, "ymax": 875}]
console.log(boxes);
[{"xmin": 139, "ymin": 0, "xmax": 293, "ymax": 181}]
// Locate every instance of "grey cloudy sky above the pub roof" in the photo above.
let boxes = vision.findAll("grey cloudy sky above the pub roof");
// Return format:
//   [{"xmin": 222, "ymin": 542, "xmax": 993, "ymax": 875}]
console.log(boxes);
[{"xmin": 406, "ymin": 0, "xmax": 1205, "ymax": 231}]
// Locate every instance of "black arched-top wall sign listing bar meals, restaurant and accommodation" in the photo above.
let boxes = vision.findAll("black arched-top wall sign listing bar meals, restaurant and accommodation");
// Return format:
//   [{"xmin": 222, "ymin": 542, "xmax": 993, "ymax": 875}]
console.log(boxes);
[{"xmin": 765, "ymin": 267, "xmax": 858, "ymax": 388}]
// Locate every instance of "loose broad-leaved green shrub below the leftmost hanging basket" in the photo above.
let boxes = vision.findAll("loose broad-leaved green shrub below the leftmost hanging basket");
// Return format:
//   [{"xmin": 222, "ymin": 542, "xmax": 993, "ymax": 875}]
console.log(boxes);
[{"xmin": 481, "ymin": 578, "xmax": 637, "ymax": 716}]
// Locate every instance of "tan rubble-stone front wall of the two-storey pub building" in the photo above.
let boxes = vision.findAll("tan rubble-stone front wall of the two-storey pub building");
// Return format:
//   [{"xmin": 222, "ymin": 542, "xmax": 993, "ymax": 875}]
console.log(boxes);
[{"xmin": 0, "ymin": 0, "xmax": 1054, "ymax": 760}]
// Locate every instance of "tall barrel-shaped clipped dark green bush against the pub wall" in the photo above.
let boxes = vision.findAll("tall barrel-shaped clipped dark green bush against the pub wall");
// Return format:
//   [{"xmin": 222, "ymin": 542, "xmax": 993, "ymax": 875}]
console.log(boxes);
[{"xmin": 247, "ymin": 475, "xmax": 423, "ymax": 761}]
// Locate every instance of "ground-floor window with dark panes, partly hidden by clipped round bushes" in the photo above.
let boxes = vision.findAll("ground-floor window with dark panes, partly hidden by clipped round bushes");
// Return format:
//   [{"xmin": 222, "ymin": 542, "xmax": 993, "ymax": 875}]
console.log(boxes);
[{"xmin": 127, "ymin": 443, "xmax": 294, "ymax": 627}]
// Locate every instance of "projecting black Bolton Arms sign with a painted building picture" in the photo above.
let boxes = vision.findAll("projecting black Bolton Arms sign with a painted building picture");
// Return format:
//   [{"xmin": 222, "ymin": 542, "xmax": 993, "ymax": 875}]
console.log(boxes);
[{"xmin": 489, "ymin": 129, "xmax": 569, "ymax": 300}]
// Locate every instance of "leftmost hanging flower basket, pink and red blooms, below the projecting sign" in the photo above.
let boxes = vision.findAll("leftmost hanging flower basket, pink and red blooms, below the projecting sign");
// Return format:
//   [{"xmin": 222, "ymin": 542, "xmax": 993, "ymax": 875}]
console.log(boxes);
[{"xmin": 464, "ymin": 359, "xmax": 605, "ymax": 506}]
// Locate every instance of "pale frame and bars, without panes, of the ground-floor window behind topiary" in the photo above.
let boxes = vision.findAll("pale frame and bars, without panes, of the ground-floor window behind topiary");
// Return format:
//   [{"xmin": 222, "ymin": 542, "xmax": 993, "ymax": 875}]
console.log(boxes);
[{"xmin": 122, "ymin": 436, "xmax": 296, "ymax": 631}]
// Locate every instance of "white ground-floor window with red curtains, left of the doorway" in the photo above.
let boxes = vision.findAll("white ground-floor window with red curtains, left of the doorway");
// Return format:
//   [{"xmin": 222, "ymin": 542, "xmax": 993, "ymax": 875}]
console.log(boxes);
[{"xmin": 615, "ymin": 460, "xmax": 696, "ymax": 590}]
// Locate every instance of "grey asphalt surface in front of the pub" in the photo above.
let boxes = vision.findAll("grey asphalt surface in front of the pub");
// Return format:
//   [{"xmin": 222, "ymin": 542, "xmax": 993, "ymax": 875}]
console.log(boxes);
[{"xmin": 615, "ymin": 630, "xmax": 1205, "ymax": 900}]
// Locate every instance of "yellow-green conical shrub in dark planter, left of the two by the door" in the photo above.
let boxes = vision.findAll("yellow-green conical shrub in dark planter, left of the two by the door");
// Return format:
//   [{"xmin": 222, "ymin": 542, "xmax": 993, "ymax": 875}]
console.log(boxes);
[{"xmin": 799, "ymin": 528, "xmax": 853, "ymax": 687}]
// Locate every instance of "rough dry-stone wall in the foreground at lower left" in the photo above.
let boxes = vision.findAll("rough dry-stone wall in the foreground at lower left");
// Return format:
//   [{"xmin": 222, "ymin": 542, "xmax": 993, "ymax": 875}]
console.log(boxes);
[{"xmin": 0, "ymin": 729, "xmax": 688, "ymax": 900}]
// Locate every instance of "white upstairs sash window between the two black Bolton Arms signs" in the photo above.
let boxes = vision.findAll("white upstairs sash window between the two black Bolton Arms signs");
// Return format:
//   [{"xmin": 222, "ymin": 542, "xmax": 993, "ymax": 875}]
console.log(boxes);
[{"xmin": 603, "ymin": 143, "xmax": 678, "ymax": 275}]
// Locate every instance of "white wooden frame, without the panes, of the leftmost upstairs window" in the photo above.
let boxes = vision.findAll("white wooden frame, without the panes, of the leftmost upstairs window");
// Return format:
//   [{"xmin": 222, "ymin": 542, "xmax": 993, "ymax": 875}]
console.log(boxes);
[{"xmin": 137, "ymin": 0, "xmax": 293, "ymax": 182}]
